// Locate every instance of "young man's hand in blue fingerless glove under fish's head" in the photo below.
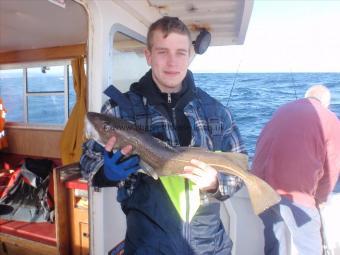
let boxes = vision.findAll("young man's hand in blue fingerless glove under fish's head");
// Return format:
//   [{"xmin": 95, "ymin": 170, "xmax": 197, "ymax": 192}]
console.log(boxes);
[{"xmin": 104, "ymin": 136, "xmax": 140, "ymax": 181}]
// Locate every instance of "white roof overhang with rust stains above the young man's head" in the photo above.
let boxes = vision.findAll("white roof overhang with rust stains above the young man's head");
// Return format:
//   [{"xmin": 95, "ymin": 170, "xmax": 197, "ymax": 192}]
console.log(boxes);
[{"xmin": 118, "ymin": 0, "xmax": 253, "ymax": 46}]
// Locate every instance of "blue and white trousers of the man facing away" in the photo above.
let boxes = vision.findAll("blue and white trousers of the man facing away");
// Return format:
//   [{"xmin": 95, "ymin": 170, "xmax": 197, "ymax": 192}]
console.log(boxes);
[{"xmin": 260, "ymin": 198, "xmax": 322, "ymax": 255}]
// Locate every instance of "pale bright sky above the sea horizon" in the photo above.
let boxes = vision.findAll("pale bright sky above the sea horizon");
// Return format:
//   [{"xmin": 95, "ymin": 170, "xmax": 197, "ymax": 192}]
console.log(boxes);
[{"xmin": 190, "ymin": 0, "xmax": 340, "ymax": 72}]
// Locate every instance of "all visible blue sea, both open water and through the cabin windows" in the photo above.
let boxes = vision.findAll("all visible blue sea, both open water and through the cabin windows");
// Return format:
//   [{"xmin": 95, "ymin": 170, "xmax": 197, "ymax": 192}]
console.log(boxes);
[{"xmin": 0, "ymin": 73, "xmax": 340, "ymax": 158}]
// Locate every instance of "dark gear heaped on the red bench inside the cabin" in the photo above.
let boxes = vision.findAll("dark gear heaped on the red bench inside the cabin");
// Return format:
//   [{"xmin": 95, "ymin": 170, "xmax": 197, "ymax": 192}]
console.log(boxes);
[{"xmin": 0, "ymin": 158, "xmax": 54, "ymax": 222}]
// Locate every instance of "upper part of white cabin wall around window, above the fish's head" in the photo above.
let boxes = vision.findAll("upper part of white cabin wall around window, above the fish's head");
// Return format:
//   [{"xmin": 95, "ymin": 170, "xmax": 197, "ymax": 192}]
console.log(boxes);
[{"xmin": 87, "ymin": 0, "xmax": 160, "ymax": 111}]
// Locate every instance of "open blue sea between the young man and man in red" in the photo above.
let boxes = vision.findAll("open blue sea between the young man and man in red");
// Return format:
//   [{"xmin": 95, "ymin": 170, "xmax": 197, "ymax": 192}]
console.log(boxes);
[{"xmin": 194, "ymin": 73, "xmax": 340, "ymax": 158}]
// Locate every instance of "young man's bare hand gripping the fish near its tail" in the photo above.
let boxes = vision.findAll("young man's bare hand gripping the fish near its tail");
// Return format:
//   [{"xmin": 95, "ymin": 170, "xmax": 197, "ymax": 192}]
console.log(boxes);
[{"xmin": 181, "ymin": 159, "xmax": 218, "ymax": 193}]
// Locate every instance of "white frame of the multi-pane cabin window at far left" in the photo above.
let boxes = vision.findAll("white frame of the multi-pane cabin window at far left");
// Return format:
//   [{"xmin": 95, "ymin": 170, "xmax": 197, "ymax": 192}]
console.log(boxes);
[{"xmin": 0, "ymin": 59, "xmax": 72, "ymax": 130}]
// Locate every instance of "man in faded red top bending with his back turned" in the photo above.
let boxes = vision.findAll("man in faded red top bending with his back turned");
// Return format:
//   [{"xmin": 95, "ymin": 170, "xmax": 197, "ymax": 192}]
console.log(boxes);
[{"xmin": 252, "ymin": 85, "xmax": 340, "ymax": 255}]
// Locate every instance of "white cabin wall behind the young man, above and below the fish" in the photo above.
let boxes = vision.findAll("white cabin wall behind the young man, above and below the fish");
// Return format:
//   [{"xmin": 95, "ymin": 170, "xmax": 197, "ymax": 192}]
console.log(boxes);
[{"xmin": 84, "ymin": 0, "xmax": 160, "ymax": 254}]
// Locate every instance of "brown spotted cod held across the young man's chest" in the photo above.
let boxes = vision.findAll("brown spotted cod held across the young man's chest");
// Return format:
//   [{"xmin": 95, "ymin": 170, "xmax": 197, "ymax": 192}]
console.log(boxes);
[{"xmin": 86, "ymin": 112, "xmax": 280, "ymax": 215}]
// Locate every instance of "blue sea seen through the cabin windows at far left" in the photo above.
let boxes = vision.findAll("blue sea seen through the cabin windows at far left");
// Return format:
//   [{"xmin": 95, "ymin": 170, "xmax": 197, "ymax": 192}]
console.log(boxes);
[{"xmin": 0, "ymin": 73, "xmax": 76, "ymax": 125}]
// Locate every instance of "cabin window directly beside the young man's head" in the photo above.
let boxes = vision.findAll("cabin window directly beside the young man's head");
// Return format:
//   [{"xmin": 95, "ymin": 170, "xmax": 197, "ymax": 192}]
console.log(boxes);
[{"xmin": 111, "ymin": 28, "xmax": 149, "ymax": 91}]
